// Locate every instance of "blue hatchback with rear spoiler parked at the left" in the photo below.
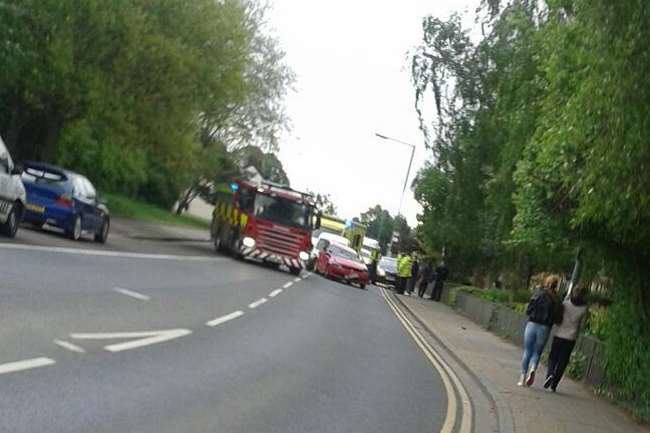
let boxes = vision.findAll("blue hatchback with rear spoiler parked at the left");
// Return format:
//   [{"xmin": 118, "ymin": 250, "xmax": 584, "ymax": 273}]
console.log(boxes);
[{"xmin": 22, "ymin": 161, "xmax": 111, "ymax": 243}]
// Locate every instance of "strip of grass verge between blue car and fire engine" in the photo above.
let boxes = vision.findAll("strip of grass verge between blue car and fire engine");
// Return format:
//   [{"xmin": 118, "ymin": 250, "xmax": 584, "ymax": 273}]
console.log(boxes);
[{"xmin": 105, "ymin": 194, "xmax": 210, "ymax": 228}]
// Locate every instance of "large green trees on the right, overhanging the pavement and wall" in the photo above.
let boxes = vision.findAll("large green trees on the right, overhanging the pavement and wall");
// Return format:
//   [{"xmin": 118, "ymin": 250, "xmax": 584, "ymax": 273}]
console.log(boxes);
[{"xmin": 412, "ymin": 0, "xmax": 650, "ymax": 417}]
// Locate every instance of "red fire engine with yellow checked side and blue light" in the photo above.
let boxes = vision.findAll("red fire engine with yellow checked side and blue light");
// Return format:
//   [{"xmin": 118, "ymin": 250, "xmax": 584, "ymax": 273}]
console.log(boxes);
[{"xmin": 210, "ymin": 180, "xmax": 320, "ymax": 275}]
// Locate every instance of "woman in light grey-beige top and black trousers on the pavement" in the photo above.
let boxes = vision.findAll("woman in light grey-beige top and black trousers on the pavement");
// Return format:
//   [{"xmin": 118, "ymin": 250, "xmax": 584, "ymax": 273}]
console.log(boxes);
[{"xmin": 544, "ymin": 287, "xmax": 588, "ymax": 392}]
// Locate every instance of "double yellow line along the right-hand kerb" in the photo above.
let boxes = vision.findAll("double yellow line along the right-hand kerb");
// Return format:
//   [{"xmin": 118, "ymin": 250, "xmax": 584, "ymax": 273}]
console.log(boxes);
[{"xmin": 381, "ymin": 288, "xmax": 473, "ymax": 433}]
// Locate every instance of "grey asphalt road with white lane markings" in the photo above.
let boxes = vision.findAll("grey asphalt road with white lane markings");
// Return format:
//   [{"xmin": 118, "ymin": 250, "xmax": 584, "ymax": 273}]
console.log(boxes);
[{"xmin": 0, "ymin": 222, "xmax": 460, "ymax": 433}]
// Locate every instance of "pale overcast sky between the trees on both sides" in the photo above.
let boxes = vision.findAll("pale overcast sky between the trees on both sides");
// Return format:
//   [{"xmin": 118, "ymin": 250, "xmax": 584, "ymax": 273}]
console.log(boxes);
[{"xmin": 269, "ymin": 0, "xmax": 479, "ymax": 225}]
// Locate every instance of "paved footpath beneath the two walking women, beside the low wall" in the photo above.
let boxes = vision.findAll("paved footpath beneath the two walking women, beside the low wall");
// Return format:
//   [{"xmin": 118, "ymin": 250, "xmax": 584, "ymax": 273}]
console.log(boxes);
[{"xmin": 394, "ymin": 295, "xmax": 650, "ymax": 433}]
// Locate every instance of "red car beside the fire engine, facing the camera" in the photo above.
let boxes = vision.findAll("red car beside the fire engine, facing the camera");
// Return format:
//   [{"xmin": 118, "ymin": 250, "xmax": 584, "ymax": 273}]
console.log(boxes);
[{"xmin": 316, "ymin": 244, "xmax": 368, "ymax": 289}]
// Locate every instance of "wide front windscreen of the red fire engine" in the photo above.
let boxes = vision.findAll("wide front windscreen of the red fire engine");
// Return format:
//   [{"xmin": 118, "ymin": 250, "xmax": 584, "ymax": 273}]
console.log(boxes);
[{"xmin": 254, "ymin": 193, "xmax": 312, "ymax": 230}]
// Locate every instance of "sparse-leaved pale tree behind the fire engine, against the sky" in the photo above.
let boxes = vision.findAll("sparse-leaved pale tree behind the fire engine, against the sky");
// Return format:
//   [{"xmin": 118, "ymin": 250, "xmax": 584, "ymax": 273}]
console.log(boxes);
[{"xmin": 173, "ymin": 0, "xmax": 295, "ymax": 209}]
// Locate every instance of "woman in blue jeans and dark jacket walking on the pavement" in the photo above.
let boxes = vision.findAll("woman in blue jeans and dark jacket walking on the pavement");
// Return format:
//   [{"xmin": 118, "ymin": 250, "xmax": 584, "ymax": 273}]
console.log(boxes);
[{"xmin": 517, "ymin": 276, "xmax": 562, "ymax": 386}]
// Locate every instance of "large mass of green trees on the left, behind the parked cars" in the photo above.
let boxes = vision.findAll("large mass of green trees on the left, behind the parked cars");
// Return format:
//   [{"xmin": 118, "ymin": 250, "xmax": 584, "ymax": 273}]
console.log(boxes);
[{"xmin": 0, "ymin": 0, "xmax": 293, "ymax": 207}]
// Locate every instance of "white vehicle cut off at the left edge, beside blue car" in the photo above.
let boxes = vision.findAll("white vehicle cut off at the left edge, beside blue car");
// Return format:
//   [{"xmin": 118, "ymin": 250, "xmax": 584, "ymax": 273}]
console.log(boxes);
[{"xmin": 0, "ymin": 137, "xmax": 26, "ymax": 238}]
